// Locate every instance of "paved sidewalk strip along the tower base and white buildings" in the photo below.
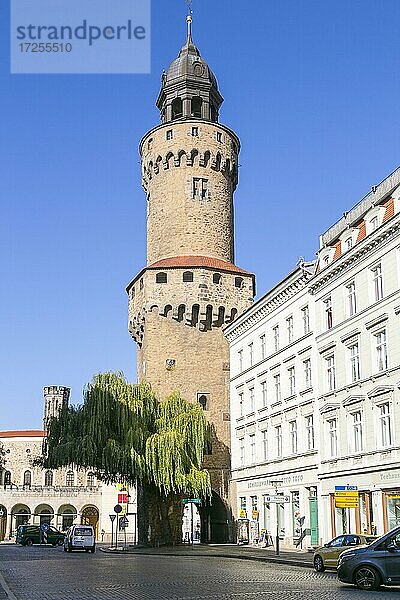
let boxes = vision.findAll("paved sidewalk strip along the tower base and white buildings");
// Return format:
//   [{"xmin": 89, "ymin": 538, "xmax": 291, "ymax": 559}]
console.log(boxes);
[{"xmin": 100, "ymin": 544, "xmax": 313, "ymax": 568}]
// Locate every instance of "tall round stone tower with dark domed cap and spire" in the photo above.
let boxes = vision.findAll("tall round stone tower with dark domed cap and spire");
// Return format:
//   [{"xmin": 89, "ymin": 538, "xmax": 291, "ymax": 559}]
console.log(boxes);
[{"xmin": 127, "ymin": 16, "xmax": 254, "ymax": 541}]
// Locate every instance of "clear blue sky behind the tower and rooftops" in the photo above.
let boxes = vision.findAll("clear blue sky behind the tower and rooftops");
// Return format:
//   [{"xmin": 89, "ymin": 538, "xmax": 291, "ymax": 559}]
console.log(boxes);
[{"xmin": 0, "ymin": 0, "xmax": 400, "ymax": 430}]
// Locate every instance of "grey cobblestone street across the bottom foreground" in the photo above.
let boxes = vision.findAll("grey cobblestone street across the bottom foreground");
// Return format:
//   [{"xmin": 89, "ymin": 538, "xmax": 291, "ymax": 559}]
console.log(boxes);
[{"xmin": 0, "ymin": 545, "xmax": 399, "ymax": 600}]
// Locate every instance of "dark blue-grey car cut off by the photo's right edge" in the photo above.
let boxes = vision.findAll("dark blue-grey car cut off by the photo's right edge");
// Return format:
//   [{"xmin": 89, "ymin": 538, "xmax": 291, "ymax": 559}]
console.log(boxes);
[{"xmin": 338, "ymin": 527, "xmax": 400, "ymax": 590}]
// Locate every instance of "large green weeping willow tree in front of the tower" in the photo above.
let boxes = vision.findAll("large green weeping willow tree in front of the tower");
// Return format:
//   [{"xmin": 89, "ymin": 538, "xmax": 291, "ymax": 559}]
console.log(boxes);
[{"xmin": 43, "ymin": 373, "xmax": 211, "ymax": 543}]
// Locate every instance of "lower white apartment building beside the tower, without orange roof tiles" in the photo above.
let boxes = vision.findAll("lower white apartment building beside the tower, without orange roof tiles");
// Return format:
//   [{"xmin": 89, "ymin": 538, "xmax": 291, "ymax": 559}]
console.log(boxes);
[{"xmin": 225, "ymin": 262, "xmax": 319, "ymax": 545}]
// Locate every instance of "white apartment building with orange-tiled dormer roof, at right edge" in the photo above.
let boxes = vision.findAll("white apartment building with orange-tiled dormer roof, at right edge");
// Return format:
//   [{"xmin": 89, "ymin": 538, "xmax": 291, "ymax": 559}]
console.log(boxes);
[{"xmin": 310, "ymin": 169, "xmax": 400, "ymax": 540}]
